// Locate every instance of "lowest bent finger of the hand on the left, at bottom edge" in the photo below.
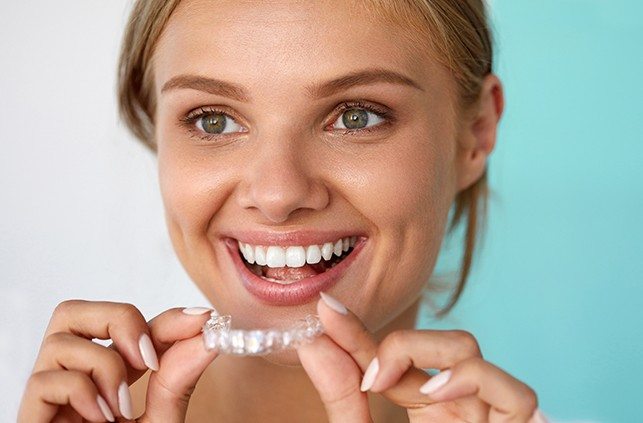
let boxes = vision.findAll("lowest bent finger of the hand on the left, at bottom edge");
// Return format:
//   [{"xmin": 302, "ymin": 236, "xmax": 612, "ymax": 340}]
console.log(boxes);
[{"xmin": 18, "ymin": 370, "xmax": 114, "ymax": 423}]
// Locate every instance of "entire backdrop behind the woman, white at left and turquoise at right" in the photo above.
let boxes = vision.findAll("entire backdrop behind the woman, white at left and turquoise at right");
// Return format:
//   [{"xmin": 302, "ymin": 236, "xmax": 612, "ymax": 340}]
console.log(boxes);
[{"xmin": 0, "ymin": 0, "xmax": 643, "ymax": 422}]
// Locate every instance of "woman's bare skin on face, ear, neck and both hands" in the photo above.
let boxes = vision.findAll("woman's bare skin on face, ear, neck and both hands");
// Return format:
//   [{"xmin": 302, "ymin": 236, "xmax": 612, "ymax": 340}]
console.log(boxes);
[{"xmin": 19, "ymin": 0, "xmax": 542, "ymax": 423}]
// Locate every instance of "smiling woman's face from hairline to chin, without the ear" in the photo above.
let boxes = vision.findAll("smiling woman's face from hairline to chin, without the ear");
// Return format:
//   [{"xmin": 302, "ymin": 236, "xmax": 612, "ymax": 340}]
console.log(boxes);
[{"xmin": 154, "ymin": 0, "xmax": 466, "ymax": 330}]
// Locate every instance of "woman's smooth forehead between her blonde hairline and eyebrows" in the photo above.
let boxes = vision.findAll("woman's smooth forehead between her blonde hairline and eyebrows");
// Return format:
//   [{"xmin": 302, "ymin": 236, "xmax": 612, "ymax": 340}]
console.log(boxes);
[{"xmin": 154, "ymin": 0, "xmax": 448, "ymax": 99}]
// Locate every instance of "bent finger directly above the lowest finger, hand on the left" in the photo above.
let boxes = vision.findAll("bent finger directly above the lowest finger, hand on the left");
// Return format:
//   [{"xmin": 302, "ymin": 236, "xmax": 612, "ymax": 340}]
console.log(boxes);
[{"xmin": 34, "ymin": 332, "xmax": 127, "ymax": 415}]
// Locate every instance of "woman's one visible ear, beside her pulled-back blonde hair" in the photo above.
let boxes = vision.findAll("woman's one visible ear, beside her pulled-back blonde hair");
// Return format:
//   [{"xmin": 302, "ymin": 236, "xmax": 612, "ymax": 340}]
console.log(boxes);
[{"xmin": 456, "ymin": 74, "xmax": 504, "ymax": 192}]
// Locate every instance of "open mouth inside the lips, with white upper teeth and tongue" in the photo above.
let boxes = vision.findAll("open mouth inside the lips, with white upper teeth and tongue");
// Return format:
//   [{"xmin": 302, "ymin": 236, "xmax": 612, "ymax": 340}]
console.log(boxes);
[{"xmin": 238, "ymin": 236, "xmax": 357, "ymax": 285}]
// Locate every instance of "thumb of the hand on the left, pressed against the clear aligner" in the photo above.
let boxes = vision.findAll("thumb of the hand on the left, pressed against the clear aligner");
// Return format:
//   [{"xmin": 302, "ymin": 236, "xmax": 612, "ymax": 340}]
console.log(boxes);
[{"xmin": 140, "ymin": 334, "xmax": 217, "ymax": 423}]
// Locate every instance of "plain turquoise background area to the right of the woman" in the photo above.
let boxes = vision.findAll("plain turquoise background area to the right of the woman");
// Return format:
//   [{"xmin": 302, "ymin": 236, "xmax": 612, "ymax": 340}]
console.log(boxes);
[{"xmin": 420, "ymin": 0, "xmax": 643, "ymax": 422}]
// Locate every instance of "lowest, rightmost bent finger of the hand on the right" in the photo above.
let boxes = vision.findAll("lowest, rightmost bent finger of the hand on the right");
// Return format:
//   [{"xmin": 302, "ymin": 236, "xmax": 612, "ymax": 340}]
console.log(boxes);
[{"xmin": 422, "ymin": 357, "xmax": 538, "ymax": 423}]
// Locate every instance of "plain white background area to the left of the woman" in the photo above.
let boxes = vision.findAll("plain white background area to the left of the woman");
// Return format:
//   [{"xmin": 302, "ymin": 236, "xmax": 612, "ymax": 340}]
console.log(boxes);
[{"xmin": 0, "ymin": 0, "xmax": 207, "ymax": 422}]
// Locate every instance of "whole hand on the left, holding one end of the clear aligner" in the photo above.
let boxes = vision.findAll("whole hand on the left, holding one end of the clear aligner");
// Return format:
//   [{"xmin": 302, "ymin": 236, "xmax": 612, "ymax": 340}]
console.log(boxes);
[{"xmin": 18, "ymin": 300, "xmax": 216, "ymax": 423}]
